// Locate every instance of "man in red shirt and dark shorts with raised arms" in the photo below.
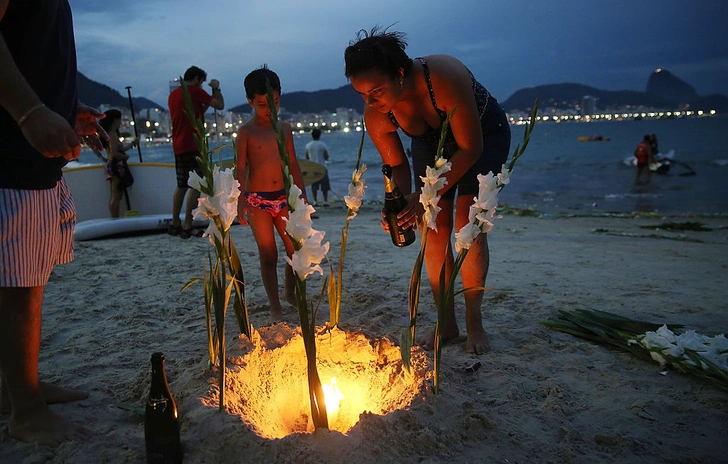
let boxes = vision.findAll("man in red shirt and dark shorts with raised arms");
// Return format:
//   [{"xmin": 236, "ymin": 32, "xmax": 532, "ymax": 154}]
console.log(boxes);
[{"xmin": 167, "ymin": 66, "xmax": 225, "ymax": 238}]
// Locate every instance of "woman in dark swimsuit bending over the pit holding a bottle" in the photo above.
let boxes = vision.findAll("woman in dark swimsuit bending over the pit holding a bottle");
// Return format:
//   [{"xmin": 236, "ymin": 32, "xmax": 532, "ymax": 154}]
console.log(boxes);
[{"xmin": 344, "ymin": 28, "xmax": 511, "ymax": 354}]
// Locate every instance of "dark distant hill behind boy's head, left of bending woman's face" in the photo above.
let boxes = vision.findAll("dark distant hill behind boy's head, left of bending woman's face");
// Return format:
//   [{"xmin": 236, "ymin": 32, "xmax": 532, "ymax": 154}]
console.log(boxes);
[{"xmin": 229, "ymin": 85, "xmax": 364, "ymax": 113}]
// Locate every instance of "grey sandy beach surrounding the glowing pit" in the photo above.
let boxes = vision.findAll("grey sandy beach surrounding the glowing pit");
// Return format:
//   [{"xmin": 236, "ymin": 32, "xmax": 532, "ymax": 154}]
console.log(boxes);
[{"xmin": 0, "ymin": 203, "xmax": 728, "ymax": 463}]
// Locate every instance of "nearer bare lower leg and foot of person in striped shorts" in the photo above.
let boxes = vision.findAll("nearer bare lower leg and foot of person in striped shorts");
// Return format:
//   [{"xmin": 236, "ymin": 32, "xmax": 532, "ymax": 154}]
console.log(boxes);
[{"xmin": 0, "ymin": 286, "xmax": 88, "ymax": 446}]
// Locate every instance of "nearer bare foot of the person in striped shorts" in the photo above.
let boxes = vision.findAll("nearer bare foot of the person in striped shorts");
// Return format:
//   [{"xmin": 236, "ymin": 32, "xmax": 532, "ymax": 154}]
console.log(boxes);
[{"xmin": 8, "ymin": 406, "xmax": 91, "ymax": 447}]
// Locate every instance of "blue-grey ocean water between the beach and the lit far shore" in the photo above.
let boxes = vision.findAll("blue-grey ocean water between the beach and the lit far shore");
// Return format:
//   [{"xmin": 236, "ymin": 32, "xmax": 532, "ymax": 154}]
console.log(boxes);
[{"xmin": 74, "ymin": 116, "xmax": 728, "ymax": 215}]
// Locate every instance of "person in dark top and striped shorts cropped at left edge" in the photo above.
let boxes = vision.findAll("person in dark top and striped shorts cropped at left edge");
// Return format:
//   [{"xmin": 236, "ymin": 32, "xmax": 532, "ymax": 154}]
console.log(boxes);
[{"xmin": 0, "ymin": 0, "xmax": 106, "ymax": 446}]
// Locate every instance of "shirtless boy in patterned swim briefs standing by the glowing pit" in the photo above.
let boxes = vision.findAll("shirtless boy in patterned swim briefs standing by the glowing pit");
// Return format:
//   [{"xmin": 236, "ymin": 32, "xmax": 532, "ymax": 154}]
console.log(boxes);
[{"xmin": 235, "ymin": 66, "xmax": 306, "ymax": 322}]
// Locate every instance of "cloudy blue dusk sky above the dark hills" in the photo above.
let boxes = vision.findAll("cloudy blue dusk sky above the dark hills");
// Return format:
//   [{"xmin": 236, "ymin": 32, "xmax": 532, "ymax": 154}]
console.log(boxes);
[{"xmin": 69, "ymin": 0, "xmax": 728, "ymax": 107}]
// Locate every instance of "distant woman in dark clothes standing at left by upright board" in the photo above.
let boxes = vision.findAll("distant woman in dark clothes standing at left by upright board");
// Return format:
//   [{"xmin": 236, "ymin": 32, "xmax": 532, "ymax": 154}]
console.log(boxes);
[{"xmin": 99, "ymin": 110, "xmax": 134, "ymax": 218}]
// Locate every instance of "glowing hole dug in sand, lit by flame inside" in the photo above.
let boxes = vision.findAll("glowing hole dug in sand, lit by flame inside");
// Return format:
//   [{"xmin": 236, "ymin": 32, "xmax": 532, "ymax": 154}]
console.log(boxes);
[{"xmin": 225, "ymin": 324, "xmax": 428, "ymax": 439}]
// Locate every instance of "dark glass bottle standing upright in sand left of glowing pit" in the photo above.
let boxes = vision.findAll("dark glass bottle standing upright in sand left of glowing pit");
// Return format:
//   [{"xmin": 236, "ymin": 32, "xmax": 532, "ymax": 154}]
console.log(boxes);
[{"xmin": 144, "ymin": 353, "xmax": 182, "ymax": 464}]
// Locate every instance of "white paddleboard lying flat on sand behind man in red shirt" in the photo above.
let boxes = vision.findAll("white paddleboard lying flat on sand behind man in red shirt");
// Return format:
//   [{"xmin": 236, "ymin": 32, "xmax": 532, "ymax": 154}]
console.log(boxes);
[{"xmin": 73, "ymin": 214, "xmax": 207, "ymax": 241}]
